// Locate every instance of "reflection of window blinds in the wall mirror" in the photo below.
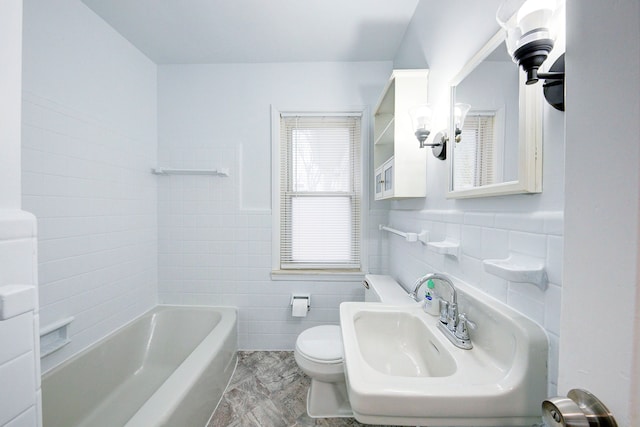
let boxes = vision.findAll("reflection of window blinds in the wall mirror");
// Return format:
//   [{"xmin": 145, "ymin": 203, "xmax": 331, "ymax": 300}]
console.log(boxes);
[{"xmin": 454, "ymin": 113, "xmax": 496, "ymax": 190}]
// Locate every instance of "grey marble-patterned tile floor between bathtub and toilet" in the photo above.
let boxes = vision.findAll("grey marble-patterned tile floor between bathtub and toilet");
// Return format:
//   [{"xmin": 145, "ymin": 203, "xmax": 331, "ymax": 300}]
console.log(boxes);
[{"xmin": 207, "ymin": 351, "xmax": 400, "ymax": 427}]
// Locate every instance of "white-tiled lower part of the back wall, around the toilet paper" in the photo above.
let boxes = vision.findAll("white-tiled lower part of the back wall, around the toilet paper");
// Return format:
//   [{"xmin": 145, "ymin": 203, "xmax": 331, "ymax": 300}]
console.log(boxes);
[{"xmin": 158, "ymin": 147, "xmax": 387, "ymax": 350}]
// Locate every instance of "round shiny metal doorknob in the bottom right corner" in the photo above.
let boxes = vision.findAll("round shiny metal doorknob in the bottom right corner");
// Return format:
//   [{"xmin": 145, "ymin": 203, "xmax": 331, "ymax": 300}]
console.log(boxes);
[{"xmin": 542, "ymin": 388, "xmax": 618, "ymax": 427}]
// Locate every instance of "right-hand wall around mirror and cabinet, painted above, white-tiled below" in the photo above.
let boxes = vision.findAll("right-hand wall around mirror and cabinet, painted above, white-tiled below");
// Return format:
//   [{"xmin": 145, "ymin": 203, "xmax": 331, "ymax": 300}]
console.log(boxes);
[{"xmin": 389, "ymin": 0, "xmax": 564, "ymax": 394}]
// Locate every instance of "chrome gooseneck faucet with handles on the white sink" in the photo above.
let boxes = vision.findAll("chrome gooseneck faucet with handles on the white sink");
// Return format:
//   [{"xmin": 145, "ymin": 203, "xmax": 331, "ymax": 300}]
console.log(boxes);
[{"xmin": 409, "ymin": 273, "xmax": 476, "ymax": 350}]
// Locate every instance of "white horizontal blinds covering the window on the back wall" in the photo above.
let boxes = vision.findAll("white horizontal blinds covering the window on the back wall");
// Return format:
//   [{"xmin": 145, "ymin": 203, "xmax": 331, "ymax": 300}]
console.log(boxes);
[{"xmin": 280, "ymin": 115, "xmax": 361, "ymax": 269}]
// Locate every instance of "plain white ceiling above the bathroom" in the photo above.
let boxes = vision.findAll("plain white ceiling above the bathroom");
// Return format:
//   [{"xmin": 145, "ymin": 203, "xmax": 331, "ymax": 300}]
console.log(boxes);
[{"xmin": 82, "ymin": 0, "xmax": 419, "ymax": 64}]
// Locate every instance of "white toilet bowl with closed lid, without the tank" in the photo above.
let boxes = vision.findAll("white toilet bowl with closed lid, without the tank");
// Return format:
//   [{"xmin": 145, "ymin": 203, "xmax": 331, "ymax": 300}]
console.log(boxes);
[{"xmin": 294, "ymin": 325, "xmax": 353, "ymax": 418}]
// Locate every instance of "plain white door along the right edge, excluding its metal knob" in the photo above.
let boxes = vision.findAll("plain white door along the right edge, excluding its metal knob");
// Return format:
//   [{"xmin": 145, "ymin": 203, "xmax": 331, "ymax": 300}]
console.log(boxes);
[{"xmin": 559, "ymin": 0, "xmax": 640, "ymax": 426}]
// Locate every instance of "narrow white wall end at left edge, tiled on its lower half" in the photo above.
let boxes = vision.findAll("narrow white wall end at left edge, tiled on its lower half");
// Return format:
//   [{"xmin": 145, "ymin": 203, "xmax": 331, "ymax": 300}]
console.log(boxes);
[{"xmin": 0, "ymin": 0, "xmax": 42, "ymax": 427}]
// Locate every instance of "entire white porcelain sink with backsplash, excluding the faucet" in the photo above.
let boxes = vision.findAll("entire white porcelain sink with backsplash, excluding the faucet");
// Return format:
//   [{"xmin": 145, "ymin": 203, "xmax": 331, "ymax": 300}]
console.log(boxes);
[{"xmin": 340, "ymin": 284, "xmax": 548, "ymax": 427}]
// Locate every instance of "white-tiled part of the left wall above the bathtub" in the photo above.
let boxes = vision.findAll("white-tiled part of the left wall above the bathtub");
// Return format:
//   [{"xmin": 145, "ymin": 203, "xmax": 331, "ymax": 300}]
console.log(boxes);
[{"xmin": 22, "ymin": 93, "xmax": 157, "ymax": 371}]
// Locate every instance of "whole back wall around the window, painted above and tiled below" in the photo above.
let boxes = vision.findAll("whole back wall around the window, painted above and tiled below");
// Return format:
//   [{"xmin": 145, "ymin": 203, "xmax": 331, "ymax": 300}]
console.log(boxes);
[{"xmin": 158, "ymin": 62, "xmax": 391, "ymax": 350}]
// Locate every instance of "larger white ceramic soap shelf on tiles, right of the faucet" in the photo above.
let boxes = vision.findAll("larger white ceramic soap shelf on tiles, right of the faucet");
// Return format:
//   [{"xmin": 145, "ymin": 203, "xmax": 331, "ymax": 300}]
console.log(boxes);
[{"xmin": 482, "ymin": 254, "xmax": 548, "ymax": 291}]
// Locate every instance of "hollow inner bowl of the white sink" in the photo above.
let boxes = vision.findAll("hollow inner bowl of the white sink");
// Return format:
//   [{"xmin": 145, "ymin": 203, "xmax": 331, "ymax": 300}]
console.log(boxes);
[{"xmin": 353, "ymin": 310, "xmax": 456, "ymax": 377}]
